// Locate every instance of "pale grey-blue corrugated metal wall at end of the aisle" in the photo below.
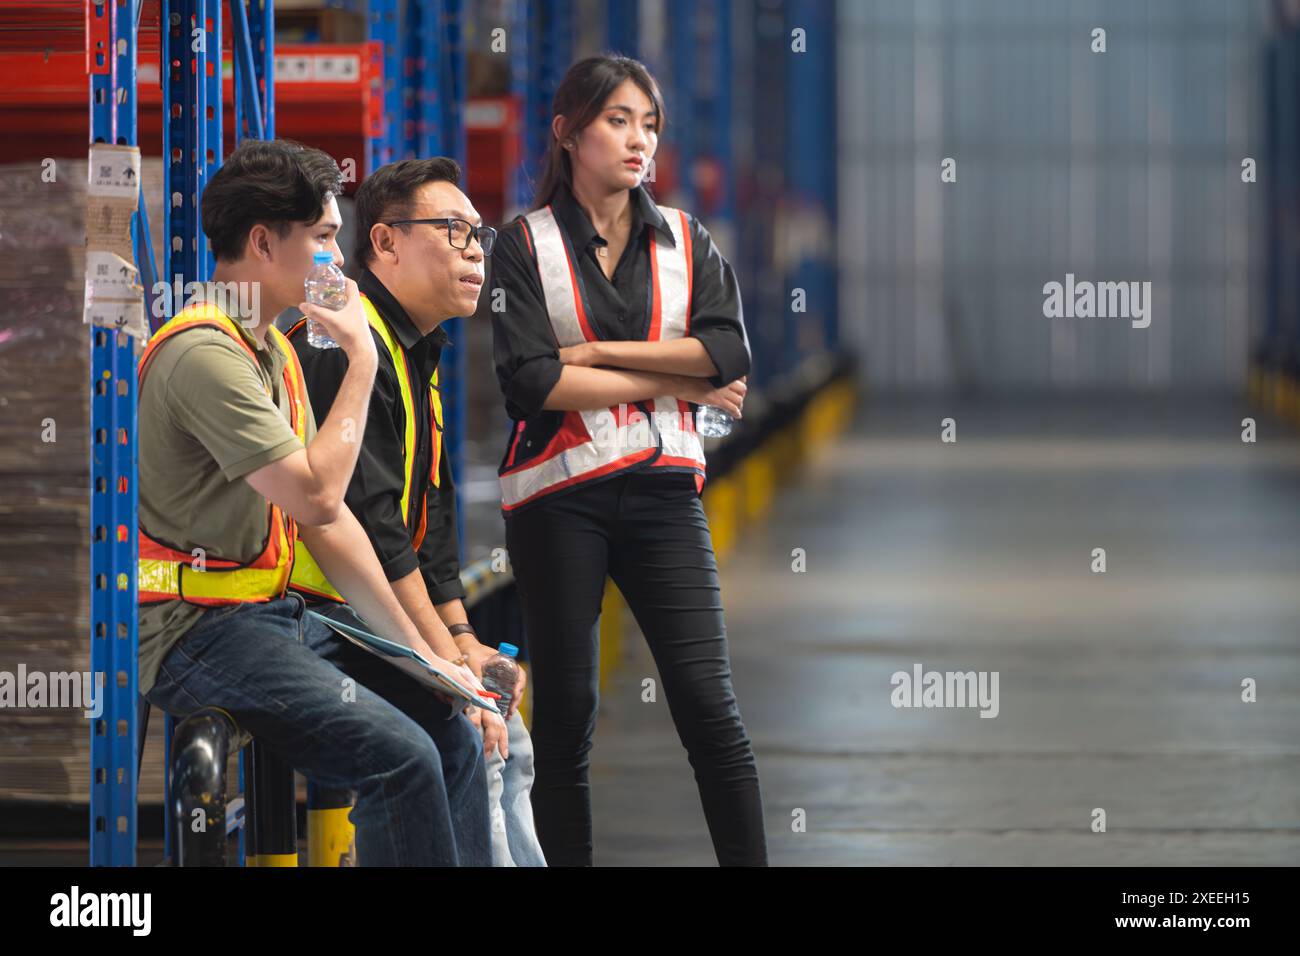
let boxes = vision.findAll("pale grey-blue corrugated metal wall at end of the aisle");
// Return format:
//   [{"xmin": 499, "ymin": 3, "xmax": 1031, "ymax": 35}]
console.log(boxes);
[{"xmin": 839, "ymin": 0, "xmax": 1273, "ymax": 390}]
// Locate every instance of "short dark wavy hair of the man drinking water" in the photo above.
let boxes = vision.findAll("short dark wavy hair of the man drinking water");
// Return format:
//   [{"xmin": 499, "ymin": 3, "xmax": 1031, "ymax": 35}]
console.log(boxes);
[{"xmin": 202, "ymin": 139, "xmax": 343, "ymax": 261}]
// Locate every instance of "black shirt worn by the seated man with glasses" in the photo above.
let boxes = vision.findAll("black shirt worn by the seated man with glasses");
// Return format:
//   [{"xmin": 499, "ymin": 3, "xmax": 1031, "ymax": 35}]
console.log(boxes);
[{"xmin": 291, "ymin": 269, "xmax": 465, "ymax": 604}]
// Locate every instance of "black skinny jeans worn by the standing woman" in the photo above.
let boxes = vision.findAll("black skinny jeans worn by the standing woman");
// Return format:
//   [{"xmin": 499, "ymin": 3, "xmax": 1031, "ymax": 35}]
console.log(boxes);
[{"xmin": 506, "ymin": 470, "xmax": 767, "ymax": 866}]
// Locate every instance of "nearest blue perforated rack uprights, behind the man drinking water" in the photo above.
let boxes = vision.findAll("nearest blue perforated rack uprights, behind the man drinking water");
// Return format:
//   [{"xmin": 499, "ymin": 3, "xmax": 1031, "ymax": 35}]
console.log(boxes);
[{"xmin": 86, "ymin": 0, "xmax": 274, "ymax": 866}]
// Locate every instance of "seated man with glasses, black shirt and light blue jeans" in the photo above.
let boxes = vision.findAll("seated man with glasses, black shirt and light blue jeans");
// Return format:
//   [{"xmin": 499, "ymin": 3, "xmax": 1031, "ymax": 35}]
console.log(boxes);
[{"xmin": 290, "ymin": 157, "xmax": 546, "ymax": 866}]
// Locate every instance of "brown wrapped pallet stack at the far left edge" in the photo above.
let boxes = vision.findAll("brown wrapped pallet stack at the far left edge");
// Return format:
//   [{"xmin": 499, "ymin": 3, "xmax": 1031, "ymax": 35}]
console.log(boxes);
[{"xmin": 0, "ymin": 159, "xmax": 171, "ymax": 804}]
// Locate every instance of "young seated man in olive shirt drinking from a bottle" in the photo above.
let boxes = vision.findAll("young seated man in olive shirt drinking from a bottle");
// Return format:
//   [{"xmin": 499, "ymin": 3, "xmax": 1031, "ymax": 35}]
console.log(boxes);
[{"xmin": 139, "ymin": 140, "xmax": 491, "ymax": 865}]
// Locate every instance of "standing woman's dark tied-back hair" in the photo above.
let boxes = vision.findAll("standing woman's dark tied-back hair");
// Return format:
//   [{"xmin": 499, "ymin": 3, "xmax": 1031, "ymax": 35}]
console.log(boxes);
[{"xmin": 533, "ymin": 53, "xmax": 667, "ymax": 209}]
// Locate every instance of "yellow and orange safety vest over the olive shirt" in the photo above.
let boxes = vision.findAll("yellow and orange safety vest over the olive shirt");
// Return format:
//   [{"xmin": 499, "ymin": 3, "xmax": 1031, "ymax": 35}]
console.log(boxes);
[{"xmin": 137, "ymin": 306, "xmax": 307, "ymax": 606}]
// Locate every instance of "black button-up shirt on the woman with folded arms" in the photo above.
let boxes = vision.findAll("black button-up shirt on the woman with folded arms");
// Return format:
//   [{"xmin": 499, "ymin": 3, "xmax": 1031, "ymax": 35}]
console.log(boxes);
[{"xmin": 480, "ymin": 185, "xmax": 750, "ymax": 421}]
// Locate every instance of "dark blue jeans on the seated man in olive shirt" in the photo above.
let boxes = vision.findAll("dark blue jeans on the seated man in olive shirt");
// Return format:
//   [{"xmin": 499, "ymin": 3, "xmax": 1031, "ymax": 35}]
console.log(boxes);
[{"xmin": 147, "ymin": 594, "xmax": 491, "ymax": 866}]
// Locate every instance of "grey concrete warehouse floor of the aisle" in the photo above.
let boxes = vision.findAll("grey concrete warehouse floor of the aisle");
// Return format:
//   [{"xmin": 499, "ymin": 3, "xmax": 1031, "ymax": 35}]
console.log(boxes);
[{"xmin": 592, "ymin": 397, "xmax": 1300, "ymax": 865}]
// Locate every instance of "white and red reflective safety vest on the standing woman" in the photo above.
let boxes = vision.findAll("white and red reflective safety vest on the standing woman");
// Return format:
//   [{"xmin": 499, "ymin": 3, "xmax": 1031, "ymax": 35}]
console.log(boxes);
[{"xmin": 499, "ymin": 206, "xmax": 705, "ymax": 512}]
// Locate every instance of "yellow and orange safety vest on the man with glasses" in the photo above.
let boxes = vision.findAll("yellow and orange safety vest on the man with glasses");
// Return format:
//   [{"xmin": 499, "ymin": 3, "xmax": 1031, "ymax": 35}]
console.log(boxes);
[{"xmin": 289, "ymin": 295, "xmax": 442, "ymax": 601}]
